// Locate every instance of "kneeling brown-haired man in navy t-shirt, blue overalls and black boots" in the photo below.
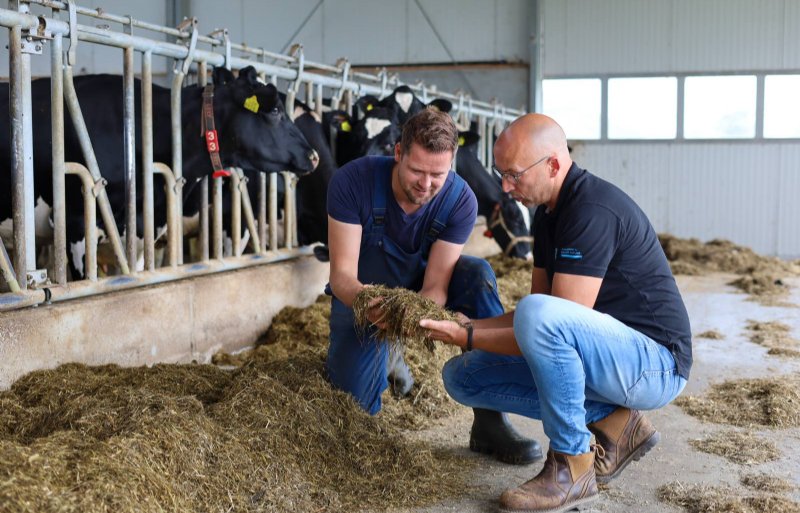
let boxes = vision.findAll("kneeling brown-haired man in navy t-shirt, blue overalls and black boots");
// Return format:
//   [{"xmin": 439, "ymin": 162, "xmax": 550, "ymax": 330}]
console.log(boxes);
[{"xmin": 326, "ymin": 110, "xmax": 542, "ymax": 464}]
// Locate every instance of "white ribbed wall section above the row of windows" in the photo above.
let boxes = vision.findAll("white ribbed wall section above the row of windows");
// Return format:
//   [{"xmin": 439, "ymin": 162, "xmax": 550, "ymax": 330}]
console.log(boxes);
[{"xmin": 543, "ymin": 0, "xmax": 800, "ymax": 76}]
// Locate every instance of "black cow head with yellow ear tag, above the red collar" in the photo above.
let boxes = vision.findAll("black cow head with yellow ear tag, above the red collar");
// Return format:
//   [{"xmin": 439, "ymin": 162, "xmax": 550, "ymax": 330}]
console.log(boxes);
[{"xmin": 214, "ymin": 66, "xmax": 319, "ymax": 175}]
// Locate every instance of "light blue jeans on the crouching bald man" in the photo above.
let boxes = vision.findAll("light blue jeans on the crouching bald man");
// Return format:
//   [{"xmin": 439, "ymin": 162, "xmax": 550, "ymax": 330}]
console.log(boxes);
[{"xmin": 442, "ymin": 294, "xmax": 686, "ymax": 454}]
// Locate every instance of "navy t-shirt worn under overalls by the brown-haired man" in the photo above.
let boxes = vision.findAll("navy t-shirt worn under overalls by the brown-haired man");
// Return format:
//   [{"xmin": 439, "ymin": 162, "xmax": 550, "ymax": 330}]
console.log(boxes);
[{"xmin": 328, "ymin": 156, "xmax": 478, "ymax": 253}]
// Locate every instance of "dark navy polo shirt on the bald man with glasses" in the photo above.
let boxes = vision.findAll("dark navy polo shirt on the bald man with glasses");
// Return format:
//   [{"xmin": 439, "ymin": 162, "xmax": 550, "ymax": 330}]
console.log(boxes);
[{"xmin": 533, "ymin": 163, "xmax": 692, "ymax": 379}]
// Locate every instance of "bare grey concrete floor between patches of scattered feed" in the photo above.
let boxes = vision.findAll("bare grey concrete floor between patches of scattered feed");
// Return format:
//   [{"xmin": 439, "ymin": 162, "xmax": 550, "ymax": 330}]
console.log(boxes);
[{"xmin": 382, "ymin": 274, "xmax": 800, "ymax": 513}]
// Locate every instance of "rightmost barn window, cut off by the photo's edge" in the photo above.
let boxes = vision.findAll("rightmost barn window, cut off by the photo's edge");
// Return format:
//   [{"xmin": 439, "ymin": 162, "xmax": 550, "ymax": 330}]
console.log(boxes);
[{"xmin": 764, "ymin": 75, "xmax": 800, "ymax": 139}]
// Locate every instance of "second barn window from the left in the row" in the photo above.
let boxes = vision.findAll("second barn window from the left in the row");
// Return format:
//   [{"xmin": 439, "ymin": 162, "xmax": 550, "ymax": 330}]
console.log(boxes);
[{"xmin": 608, "ymin": 77, "xmax": 678, "ymax": 139}]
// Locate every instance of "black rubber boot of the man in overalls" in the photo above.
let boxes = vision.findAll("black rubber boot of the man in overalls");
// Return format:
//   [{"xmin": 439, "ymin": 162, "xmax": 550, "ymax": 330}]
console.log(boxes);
[{"xmin": 469, "ymin": 408, "xmax": 542, "ymax": 465}]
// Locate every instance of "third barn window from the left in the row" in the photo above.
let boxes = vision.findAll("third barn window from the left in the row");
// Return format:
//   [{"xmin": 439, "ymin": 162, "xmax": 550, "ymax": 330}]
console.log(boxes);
[{"xmin": 683, "ymin": 76, "xmax": 756, "ymax": 139}]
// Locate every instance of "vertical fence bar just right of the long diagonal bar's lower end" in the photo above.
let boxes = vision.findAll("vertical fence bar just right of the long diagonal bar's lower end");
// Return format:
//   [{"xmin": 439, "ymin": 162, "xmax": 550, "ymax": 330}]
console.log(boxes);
[{"xmin": 142, "ymin": 51, "xmax": 156, "ymax": 271}]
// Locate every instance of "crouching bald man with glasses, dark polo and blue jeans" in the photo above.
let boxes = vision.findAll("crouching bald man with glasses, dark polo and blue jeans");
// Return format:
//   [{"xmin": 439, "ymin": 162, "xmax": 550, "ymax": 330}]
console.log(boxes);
[{"xmin": 420, "ymin": 114, "xmax": 692, "ymax": 513}]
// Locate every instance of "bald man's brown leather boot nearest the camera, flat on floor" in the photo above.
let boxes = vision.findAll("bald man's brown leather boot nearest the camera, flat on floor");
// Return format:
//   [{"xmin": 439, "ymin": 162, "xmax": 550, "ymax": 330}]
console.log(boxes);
[{"xmin": 500, "ymin": 448, "xmax": 598, "ymax": 513}]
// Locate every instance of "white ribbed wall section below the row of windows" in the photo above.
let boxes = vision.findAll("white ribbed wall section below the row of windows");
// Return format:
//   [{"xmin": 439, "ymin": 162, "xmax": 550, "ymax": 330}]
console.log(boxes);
[{"xmin": 573, "ymin": 143, "xmax": 800, "ymax": 258}]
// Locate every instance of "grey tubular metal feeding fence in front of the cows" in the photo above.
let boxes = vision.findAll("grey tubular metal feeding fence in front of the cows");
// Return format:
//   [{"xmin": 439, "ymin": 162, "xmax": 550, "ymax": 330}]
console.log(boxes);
[{"xmin": 0, "ymin": 0, "xmax": 523, "ymax": 311}]
